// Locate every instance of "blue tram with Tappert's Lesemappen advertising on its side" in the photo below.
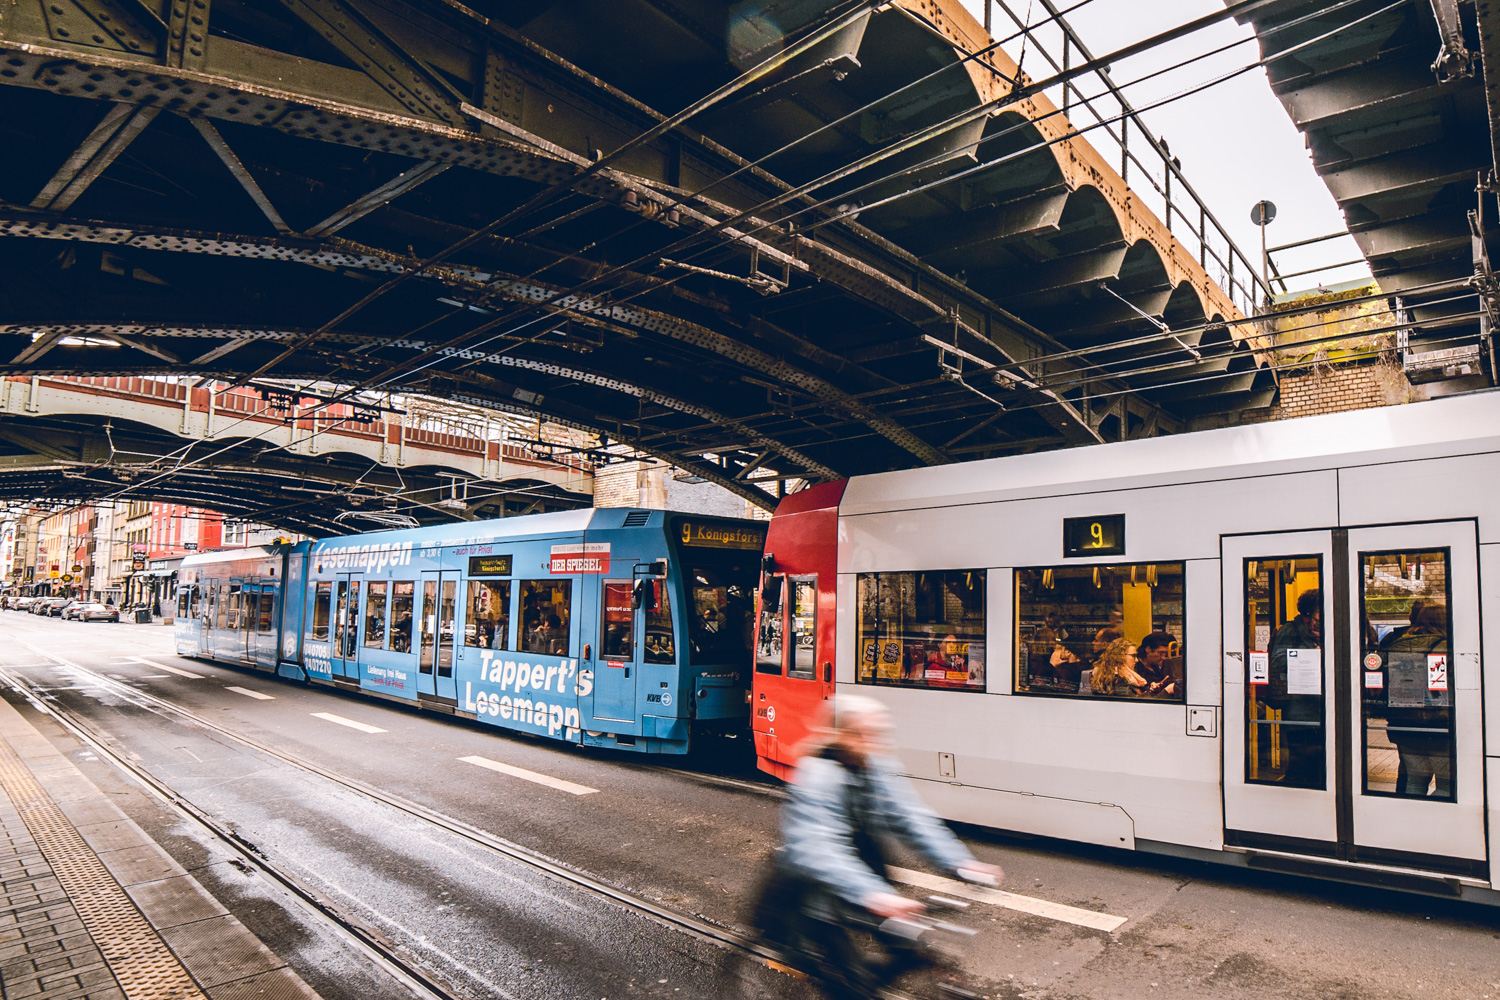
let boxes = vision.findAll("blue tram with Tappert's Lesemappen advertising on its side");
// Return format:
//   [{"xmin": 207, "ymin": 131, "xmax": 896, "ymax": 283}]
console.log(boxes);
[{"xmin": 176, "ymin": 508, "xmax": 765, "ymax": 753}]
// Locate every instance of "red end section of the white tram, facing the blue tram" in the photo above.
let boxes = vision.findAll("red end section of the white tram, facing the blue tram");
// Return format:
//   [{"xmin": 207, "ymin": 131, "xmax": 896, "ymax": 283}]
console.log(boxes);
[{"xmin": 752, "ymin": 480, "xmax": 845, "ymax": 778}]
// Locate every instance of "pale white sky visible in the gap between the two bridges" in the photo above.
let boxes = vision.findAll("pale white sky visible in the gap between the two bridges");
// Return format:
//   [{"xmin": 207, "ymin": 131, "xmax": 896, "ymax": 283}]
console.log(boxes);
[{"xmin": 963, "ymin": 0, "xmax": 1370, "ymax": 291}]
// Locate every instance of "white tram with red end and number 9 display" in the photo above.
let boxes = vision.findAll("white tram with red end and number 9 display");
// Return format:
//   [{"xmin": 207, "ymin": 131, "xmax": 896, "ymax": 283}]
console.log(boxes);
[{"xmin": 755, "ymin": 393, "xmax": 1500, "ymax": 903}]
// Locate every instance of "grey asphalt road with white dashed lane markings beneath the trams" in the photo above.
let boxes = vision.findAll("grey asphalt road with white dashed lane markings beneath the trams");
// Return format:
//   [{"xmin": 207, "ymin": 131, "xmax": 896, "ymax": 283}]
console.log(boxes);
[{"xmin": 0, "ymin": 612, "xmax": 1500, "ymax": 1000}]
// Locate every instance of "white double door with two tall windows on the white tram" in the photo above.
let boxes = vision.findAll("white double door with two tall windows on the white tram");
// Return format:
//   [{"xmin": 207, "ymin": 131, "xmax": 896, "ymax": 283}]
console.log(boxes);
[{"xmin": 1221, "ymin": 522, "xmax": 1488, "ymax": 877}]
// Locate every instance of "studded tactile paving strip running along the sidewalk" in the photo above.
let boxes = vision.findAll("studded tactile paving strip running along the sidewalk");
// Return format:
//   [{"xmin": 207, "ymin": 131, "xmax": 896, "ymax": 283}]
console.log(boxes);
[{"xmin": 0, "ymin": 738, "xmax": 204, "ymax": 1000}]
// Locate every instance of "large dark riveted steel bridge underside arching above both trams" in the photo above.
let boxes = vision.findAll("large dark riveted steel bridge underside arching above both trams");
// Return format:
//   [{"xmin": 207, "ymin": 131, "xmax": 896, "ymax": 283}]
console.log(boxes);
[{"xmin": 0, "ymin": 0, "xmax": 1274, "ymax": 523}]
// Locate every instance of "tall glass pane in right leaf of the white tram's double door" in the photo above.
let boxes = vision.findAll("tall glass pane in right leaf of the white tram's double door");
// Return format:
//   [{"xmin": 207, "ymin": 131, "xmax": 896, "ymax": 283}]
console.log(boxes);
[{"xmin": 1359, "ymin": 549, "xmax": 1458, "ymax": 802}]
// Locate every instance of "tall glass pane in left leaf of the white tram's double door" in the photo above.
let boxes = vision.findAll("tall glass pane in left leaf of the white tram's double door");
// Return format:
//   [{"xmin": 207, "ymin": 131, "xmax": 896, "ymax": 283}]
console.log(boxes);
[{"xmin": 1245, "ymin": 556, "xmax": 1328, "ymax": 789}]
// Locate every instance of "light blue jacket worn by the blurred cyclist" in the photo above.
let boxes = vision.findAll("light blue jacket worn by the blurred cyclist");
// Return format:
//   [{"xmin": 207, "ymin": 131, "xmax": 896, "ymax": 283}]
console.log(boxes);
[{"xmin": 780, "ymin": 750, "xmax": 974, "ymax": 907}]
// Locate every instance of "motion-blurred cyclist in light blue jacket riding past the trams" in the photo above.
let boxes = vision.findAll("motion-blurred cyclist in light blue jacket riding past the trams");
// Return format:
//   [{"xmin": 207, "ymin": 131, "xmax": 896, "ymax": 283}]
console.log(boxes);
[{"xmin": 755, "ymin": 694, "xmax": 1005, "ymax": 1000}]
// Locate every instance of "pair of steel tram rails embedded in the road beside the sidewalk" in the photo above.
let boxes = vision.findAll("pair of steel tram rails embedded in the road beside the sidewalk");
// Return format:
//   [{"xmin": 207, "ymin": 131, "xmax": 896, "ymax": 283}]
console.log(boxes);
[{"xmin": 0, "ymin": 639, "xmax": 921, "ymax": 1000}]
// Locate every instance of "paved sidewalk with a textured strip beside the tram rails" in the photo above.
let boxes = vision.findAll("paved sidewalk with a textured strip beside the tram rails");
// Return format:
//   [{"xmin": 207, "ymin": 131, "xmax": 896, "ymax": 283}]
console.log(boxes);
[{"xmin": 0, "ymin": 700, "xmax": 317, "ymax": 1000}]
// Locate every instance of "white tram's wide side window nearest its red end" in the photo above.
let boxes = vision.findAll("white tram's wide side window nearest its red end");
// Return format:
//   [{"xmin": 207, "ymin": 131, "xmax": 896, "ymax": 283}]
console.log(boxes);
[{"xmin": 858, "ymin": 570, "xmax": 986, "ymax": 691}]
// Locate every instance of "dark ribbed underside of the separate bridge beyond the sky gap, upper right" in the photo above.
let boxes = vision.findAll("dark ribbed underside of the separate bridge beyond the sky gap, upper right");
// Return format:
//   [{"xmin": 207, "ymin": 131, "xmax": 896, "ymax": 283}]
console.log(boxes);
[{"xmin": 1251, "ymin": 0, "xmax": 1500, "ymax": 388}]
